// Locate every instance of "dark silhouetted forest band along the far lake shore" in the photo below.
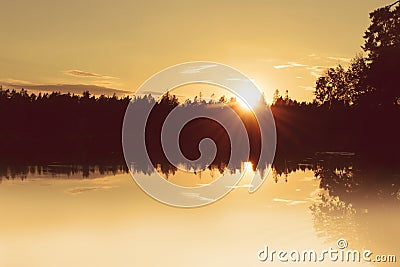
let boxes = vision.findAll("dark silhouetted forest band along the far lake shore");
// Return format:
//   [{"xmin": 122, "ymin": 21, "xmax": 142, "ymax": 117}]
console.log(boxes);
[{"xmin": 0, "ymin": 85, "xmax": 400, "ymax": 169}]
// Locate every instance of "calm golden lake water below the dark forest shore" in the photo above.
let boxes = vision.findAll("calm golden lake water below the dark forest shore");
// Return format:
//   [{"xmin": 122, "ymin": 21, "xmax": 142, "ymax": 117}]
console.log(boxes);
[{"xmin": 0, "ymin": 160, "xmax": 400, "ymax": 267}]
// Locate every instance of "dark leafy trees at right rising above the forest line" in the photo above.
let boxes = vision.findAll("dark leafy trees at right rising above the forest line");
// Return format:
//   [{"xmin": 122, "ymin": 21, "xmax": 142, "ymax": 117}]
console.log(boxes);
[{"xmin": 315, "ymin": 1, "xmax": 400, "ymax": 107}]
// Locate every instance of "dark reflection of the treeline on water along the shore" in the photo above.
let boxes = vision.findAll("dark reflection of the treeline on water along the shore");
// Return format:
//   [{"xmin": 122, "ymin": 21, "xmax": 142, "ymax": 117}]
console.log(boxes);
[{"xmin": 0, "ymin": 152, "xmax": 400, "ymax": 207}]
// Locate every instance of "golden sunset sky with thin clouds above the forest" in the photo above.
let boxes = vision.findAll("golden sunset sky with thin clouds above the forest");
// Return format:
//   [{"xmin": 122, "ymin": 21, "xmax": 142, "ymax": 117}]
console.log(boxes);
[{"xmin": 0, "ymin": 0, "xmax": 394, "ymax": 101}]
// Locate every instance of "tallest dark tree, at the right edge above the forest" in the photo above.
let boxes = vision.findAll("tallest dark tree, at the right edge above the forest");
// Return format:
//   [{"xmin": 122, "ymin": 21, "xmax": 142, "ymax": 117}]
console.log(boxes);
[{"xmin": 362, "ymin": 1, "xmax": 400, "ymax": 107}]
